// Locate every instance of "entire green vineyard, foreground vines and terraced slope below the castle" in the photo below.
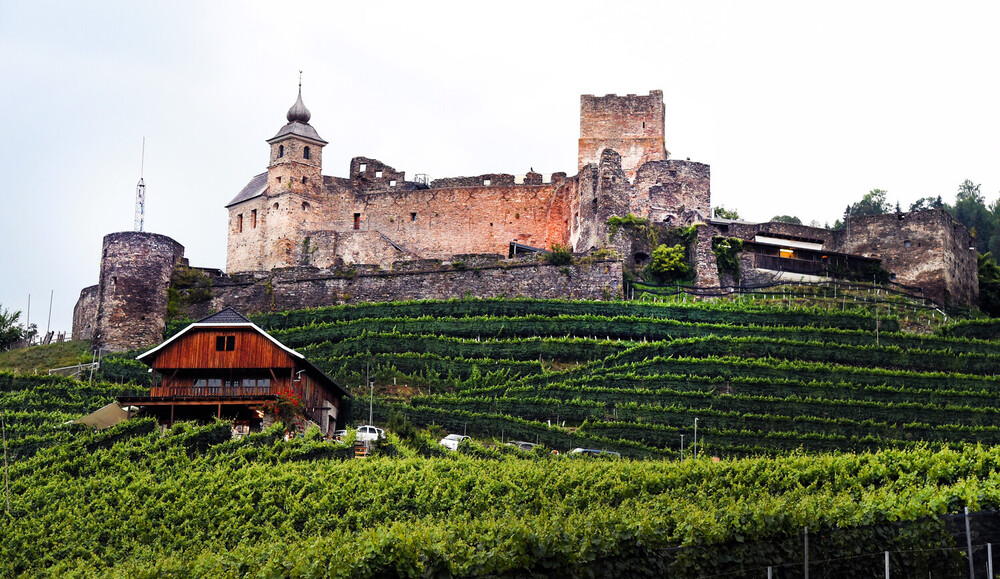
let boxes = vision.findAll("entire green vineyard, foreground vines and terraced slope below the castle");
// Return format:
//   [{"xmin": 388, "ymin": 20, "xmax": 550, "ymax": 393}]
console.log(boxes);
[{"xmin": 0, "ymin": 299, "xmax": 1000, "ymax": 577}]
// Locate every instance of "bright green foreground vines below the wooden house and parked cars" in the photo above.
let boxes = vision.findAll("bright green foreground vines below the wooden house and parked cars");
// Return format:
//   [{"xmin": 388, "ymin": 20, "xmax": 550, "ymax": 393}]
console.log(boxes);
[{"xmin": 0, "ymin": 420, "xmax": 1000, "ymax": 577}]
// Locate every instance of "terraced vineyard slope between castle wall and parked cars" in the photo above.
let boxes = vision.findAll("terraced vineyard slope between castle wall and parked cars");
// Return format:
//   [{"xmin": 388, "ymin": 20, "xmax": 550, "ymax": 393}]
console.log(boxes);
[{"xmin": 213, "ymin": 300, "xmax": 1000, "ymax": 457}]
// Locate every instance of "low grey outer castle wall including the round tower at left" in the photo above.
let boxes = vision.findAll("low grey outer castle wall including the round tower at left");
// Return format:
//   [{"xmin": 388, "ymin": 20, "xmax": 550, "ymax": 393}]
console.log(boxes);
[{"xmin": 73, "ymin": 232, "xmax": 622, "ymax": 351}]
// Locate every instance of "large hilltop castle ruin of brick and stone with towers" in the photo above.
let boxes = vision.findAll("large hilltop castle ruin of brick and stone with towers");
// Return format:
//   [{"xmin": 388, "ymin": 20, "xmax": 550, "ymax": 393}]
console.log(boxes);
[{"xmin": 73, "ymin": 86, "xmax": 978, "ymax": 350}]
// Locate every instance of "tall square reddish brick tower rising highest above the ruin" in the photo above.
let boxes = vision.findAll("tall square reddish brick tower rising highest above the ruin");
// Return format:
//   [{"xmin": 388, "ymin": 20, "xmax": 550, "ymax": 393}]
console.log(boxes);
[{"xmin": 579, "ymin": 90, "xmax": 670, "ymax": 180}]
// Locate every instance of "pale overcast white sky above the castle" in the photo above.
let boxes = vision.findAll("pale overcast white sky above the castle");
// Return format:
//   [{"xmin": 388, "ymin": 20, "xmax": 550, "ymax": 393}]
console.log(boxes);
[{"xmin": 0, "ymin": 0, "xmax": 1000, "ymax": 331}]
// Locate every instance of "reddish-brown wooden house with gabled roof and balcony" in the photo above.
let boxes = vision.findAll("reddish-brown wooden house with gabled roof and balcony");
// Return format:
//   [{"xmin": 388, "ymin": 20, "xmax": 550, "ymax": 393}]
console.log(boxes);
[{"xmin": 118, "ymin": 308, "xmax": 349, "ymax": 433}]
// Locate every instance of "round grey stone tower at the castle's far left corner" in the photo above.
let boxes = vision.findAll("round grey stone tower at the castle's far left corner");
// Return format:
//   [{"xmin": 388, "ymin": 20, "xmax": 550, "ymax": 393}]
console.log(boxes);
[{"xmin": 94, "ymin": 231, "xmax": 184, "ymax": 351}]
